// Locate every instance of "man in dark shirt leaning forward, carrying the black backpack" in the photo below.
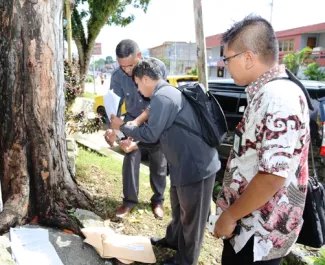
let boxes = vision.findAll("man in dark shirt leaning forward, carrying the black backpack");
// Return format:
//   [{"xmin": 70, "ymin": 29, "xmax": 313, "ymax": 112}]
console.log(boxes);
[{"xmin": 111, "ymin": 60, "xmax": 220, "ymax": 265}]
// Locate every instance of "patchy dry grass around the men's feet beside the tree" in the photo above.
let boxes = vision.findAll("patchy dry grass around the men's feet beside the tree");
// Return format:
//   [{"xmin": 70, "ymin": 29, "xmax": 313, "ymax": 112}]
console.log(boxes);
[{"xmin": 76, "ymin": 149, "xmax": 222, "ymax": 265}]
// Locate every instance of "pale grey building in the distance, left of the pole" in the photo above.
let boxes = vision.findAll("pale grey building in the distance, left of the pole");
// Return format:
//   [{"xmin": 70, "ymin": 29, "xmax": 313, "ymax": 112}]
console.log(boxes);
[{"xmin": 149, "ymin": 41, "xmax": 197, "ymax": 74}]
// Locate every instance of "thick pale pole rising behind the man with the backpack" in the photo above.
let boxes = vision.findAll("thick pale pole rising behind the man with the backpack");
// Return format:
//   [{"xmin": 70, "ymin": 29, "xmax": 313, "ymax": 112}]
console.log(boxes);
[{"xmin": 193, "ymin": 0, "xmax": 208, "ymax": 90}]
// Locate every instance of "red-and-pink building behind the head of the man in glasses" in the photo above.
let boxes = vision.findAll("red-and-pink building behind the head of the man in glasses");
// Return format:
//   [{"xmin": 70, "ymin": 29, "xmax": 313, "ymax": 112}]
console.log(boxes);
[{"xmin": 206, "ymin": 23, "xmax": 325, "ymax": 78}]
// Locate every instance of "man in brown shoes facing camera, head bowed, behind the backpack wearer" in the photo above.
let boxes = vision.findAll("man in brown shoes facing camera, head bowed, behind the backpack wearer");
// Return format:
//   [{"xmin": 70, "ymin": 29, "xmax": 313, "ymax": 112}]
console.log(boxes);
[{"xmin": 105, "ymin": 39, "xmax": 167, "ymax": 219}]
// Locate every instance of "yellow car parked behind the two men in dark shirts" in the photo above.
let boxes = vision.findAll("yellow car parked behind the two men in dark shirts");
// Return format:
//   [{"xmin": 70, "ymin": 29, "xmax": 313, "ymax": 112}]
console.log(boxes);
[{"xmin": 94, "ymin": 75, "xmax": 198, "ymax": 121}]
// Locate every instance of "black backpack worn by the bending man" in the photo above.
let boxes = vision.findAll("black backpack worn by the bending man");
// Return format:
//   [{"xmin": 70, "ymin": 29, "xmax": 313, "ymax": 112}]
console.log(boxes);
[{"xmin": 174, "ymin": 83, "xmax": 228, "ymax": 147}]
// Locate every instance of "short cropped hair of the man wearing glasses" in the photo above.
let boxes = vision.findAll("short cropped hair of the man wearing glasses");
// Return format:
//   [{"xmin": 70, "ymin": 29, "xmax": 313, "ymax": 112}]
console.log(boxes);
[{"xmin": 222, "ymin": 15, "xmax": 279, "ymax": 64}]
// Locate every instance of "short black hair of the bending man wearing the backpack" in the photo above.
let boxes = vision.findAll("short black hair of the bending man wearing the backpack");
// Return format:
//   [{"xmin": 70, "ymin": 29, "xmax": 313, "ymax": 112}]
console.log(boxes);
[{"xmin": 132, "ymin": 58, "xmax": 162, "ymax": 80}]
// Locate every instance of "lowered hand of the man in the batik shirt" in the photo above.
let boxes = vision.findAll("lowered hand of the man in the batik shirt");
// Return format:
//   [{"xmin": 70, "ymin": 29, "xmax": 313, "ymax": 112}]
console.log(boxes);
[{"xmin": 214, "ymin": 211, "xmax": 237, "ymax": 238}]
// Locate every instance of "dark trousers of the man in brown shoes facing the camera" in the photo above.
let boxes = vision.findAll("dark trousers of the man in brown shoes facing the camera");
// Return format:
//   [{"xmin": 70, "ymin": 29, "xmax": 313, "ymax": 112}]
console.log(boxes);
[{"xmin": 122, "ymin": 145, "xmax": 167, "ymax": 207}]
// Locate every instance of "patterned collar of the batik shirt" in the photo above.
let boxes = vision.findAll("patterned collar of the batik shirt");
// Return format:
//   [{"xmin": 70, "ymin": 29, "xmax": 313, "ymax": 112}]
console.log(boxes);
[{"xmin": 245, "ymin": 65, "xmax": 285, "ymax": 100}]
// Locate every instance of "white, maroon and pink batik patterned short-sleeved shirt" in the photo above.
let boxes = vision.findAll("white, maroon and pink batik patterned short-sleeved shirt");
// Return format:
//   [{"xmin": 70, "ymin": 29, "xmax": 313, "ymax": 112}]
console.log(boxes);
[{"xmin": 217, "ymin": 67, "xmax": 310, "ymax": 261}]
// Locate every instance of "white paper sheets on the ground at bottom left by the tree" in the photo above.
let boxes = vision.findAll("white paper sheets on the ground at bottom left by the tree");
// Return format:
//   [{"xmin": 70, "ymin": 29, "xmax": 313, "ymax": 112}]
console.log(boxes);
[{"xmin": 10, "ymin": 228, "xmax": 63, "ymax": 265}]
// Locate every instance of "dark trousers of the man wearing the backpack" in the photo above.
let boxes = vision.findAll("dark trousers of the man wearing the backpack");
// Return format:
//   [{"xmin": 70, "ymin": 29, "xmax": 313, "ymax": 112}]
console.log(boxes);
[{"xmin": 165, "ymin": 176, "xmax": 215, "ymax": 265}]
